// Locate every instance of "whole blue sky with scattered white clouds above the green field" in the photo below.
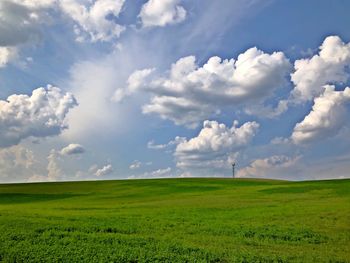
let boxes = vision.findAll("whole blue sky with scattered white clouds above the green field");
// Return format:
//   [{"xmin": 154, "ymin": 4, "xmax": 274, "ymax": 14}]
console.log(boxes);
[{"xmin": 0, "ymin": 0, "xmax": 350, "ymax": 183}]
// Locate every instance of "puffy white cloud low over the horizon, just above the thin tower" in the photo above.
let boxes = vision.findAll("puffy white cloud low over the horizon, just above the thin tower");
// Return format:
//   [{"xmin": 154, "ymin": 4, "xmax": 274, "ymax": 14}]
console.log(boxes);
[{"xmin": 174, "ymin": 121, "xmax": 259, "ymax": 169}]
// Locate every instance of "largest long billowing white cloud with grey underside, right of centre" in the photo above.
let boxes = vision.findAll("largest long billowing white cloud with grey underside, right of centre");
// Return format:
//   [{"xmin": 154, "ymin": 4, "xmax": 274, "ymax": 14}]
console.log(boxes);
[{"xmin": 121, "ymin": 47, "xmax": 291, "ymax": 127}]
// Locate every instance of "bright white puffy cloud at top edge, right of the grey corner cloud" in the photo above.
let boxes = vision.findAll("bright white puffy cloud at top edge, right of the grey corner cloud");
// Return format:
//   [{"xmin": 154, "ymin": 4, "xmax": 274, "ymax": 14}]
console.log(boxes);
[{"xmin": 60, "ymin": 0, "xmax": 125, "ymax": 42}]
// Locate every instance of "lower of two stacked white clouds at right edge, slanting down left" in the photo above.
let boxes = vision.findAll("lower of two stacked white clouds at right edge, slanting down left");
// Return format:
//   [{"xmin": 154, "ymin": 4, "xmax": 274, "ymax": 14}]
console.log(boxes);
[{"xmin": 291, "ymin": 86, "xmax": 350, "ymax": 144}]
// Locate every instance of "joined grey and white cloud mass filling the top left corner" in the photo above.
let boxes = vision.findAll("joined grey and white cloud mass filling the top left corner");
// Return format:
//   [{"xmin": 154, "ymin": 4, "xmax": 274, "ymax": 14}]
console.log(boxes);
[{"xmin": 0, "ymin": 0, "xmax": 125, "ymax": 63}]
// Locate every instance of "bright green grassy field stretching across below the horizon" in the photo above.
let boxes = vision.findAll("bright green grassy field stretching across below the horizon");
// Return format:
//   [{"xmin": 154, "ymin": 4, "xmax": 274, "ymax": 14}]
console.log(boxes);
[{"xmin": 0, "ymin": 179, "xmax": 350, "ymax": 262}]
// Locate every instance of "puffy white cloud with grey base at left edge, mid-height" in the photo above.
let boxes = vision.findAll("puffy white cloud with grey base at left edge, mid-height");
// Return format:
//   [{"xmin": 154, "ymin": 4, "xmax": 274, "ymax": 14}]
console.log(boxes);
[{"xmin": 0, "ymin": 86, "xmax": 77, "ymax": 147}]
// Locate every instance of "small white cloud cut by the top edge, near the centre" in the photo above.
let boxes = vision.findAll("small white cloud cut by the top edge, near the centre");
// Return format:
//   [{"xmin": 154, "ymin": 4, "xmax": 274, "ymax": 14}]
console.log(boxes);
[{"xmin": 139, "ymin": 0, "xmax": 187, "ymax": 27}]
